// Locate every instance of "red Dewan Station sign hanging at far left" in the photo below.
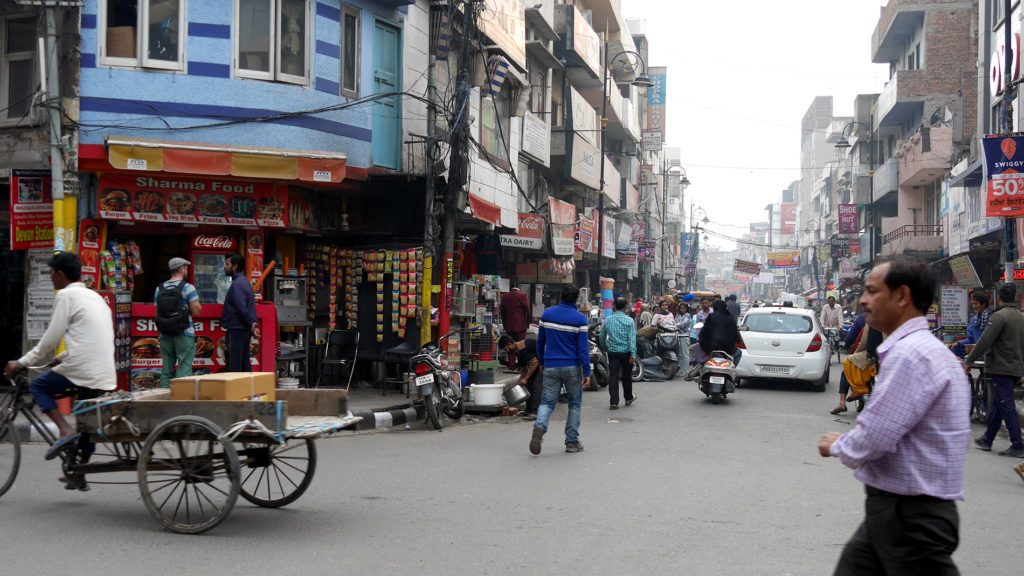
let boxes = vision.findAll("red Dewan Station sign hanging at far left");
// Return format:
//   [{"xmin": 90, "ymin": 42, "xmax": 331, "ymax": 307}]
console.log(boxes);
[{"xmin": 10, "ymin": 170, "xmax": 53, "ymax": 250}]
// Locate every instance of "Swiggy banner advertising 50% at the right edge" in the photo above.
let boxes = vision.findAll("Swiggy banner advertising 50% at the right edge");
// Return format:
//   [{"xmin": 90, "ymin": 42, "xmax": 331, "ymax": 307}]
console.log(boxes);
[{"xmin": 981, "ymin": 136, "xmax": 1024, "ymax": 218}]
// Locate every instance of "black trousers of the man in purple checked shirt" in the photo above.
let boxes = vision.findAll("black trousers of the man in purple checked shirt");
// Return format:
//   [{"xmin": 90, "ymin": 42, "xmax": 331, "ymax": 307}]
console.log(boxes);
[{"xmin": 834, "ymin": 486, "xmax": 959, "ymax": 576}]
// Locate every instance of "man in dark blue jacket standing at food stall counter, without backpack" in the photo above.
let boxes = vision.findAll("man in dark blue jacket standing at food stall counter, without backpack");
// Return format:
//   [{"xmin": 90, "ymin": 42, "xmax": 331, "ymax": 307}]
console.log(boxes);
[{"xmin": 220, "ymin": 254, "xmax": 259, "ymax": 372}]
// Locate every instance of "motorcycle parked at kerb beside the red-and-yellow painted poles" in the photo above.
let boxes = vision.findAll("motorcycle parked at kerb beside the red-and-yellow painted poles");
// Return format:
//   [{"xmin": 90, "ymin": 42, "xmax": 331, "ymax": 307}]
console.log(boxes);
[{"xmin": 412, "ymin": 332, "xmax": 466, "ymax": 430}]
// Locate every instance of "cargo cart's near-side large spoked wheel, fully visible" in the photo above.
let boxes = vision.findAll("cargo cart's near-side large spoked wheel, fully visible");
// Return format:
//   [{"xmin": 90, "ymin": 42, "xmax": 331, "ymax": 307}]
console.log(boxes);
[{"xmin": 138, "ymin": 416, "xmax": 240, "ymax": 534}]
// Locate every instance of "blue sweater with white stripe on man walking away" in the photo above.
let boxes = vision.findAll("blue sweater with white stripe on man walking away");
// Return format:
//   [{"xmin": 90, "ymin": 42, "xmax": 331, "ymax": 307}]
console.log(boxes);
[{"xmin": 537, "ymin": 302, "xmax": 590, "ymax": 378}]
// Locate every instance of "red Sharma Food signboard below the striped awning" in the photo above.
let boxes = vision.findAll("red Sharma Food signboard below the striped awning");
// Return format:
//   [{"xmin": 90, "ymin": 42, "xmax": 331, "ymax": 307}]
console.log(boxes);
[{"xmin": 98, "ymin": 174, "xmax": 288, "ymax": 228}]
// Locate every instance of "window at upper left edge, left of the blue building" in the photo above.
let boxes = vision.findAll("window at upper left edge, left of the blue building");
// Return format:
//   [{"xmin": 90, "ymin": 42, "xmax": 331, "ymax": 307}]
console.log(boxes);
[{"xmin": 0, "ymin": 13, "xmax": 39, "ymax": 124}]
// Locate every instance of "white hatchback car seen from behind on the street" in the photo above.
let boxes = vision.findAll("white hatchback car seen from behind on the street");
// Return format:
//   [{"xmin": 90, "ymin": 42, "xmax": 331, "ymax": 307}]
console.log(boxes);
[{"xmin": 736, "ymin": 306, "xmax": 831, "ymax": 392}]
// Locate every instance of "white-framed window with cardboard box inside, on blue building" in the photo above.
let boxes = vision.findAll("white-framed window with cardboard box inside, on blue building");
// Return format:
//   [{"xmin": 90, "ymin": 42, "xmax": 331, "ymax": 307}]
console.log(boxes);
[{"xmin": 99, "ymin": 0, "xmax": 185, "ymax": 70}]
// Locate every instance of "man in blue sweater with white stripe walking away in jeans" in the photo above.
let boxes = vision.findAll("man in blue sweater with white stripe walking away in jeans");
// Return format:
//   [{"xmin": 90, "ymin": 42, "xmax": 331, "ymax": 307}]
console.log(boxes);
[{"xmin": 529, "ymin": 285, "xmax": 590, "ymax": 454}]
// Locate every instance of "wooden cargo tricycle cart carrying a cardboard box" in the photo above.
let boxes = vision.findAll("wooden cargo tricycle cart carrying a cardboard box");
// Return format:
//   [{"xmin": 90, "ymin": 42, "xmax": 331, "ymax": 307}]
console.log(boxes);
[{"xmin": 0, "ymin": 377, "xmax": 362, "ymax": 534}]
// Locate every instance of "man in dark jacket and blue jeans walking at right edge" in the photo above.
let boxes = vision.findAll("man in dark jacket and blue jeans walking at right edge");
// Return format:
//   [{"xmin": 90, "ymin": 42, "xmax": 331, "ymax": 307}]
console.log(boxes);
[{"xmin": 964, "ymin": 284, "xmax": 1024, "ymax": 458}]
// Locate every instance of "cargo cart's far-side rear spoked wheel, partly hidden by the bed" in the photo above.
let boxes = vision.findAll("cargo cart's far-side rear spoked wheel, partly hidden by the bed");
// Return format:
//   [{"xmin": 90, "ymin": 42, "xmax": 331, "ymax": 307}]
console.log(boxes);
[{"xmin": 239, "ymin": 439, "xmax": 316, "ymax": 508}]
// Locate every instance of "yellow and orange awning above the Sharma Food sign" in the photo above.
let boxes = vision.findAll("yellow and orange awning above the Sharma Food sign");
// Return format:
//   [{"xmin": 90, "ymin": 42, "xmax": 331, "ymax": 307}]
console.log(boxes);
[{"xmin": 106, "ymin": 136, "xmax": 347, "ymax": 183}]
